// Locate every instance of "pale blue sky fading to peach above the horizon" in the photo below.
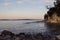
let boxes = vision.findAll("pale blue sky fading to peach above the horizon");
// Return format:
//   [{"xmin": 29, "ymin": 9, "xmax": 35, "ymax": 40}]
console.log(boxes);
[{"xmin": 0, "ymin": 0, "xmax": 54, "ymax": 19}]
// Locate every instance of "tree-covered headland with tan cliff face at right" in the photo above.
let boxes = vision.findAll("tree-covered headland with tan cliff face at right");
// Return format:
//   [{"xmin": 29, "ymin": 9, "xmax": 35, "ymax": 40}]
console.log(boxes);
[{"xmin": 44, "ymin": 0, "xmax": 60, "ymax": 23}]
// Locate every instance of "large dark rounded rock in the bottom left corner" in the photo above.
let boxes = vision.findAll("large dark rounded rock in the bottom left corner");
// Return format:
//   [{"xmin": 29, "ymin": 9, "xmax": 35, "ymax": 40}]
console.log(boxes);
[{"xmin": 0, "ymin": 30, "xmax": 15, "ymax": 40}]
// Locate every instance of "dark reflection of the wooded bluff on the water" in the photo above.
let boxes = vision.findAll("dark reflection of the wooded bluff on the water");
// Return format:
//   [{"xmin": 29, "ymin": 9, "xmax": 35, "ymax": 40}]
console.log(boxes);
[{"xmin": 45, "ymin": 23, "xmax": 60, "ymax": 35}]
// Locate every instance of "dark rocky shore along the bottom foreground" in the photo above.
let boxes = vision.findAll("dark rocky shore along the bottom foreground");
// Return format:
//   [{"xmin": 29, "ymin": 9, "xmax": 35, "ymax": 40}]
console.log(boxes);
[{"xmin": 0, "ymin": 30, "xmax": 60, "ymax": 40}]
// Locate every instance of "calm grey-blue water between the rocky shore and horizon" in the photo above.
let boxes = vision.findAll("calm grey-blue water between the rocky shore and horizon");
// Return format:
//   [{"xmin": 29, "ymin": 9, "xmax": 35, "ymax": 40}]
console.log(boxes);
[{"xmin": 0, "ymin": 20, "xmax": 60, "ymax": 35}]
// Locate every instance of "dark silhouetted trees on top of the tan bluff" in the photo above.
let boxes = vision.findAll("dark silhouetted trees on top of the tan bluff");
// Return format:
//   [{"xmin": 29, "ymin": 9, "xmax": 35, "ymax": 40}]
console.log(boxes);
[{"xmin": 44, "ymin": 0, "xmax": 60, "ymax": 19}]
